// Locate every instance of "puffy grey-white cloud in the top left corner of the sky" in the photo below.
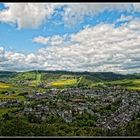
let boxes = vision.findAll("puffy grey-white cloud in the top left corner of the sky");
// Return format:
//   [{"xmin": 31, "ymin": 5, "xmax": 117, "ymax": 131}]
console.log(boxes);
[{"xmin": 0, "ymin": 3, "xmax": 54, "ymax": 28}]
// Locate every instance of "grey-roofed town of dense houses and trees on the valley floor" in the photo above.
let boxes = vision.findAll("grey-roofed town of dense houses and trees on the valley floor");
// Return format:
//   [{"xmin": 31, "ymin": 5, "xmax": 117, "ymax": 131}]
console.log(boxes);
[{"xmin": 4, "ymin": 86, "xmax": 140, "ymax": 129}]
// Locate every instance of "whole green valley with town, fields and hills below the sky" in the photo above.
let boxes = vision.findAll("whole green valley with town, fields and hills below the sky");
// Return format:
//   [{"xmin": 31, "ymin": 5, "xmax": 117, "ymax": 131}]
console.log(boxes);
[{"xmin": 0, "ymin": 71, "xmax": 140, "ymax": 136}]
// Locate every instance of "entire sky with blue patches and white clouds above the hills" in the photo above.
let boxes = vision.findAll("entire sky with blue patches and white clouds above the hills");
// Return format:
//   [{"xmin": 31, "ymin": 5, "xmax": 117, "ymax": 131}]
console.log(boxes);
[{"xmin": 0, "ymin": 3, "xmax": 140, "ymax": 74}]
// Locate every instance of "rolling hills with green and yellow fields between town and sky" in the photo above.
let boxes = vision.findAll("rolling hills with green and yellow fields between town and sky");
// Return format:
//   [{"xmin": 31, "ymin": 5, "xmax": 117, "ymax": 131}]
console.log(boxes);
[{"xmin": 0, "ymin": 70, "xmax": 140, "ymax": 89}]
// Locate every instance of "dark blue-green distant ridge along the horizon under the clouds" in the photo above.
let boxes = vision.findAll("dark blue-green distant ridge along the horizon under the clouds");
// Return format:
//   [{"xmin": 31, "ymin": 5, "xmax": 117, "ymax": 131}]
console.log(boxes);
[{"xmin": 0, "ymin": 70, "xmax": 140, "ymax": 81}]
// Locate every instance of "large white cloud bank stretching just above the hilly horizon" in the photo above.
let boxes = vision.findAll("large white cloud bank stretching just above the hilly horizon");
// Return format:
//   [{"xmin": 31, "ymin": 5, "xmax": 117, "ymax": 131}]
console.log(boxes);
[{"xmin": 0, "ymin": 15, "xmax": 140, "ymax": 73}]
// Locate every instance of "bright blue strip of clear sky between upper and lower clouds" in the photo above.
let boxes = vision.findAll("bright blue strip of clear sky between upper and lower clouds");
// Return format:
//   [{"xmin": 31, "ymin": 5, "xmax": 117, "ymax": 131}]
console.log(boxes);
[{"xmin": 0, "ymin": 4, "xmax": 135, "ymax": 53}]
